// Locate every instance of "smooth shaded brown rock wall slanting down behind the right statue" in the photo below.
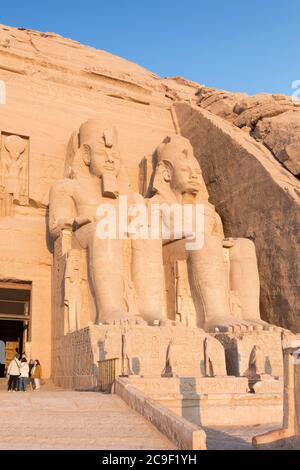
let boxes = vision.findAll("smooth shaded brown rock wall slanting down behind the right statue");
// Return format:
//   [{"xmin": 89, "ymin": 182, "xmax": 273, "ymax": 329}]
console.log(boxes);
[{"xmin": 175, "ymin": 103, "xmax": 300, "ymax": 330}]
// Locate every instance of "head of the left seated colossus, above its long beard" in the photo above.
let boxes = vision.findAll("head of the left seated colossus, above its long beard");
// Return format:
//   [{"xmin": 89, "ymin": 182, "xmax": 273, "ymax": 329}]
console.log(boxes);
[{"xmin": 79, "ymin": 119, "xmax": 121, "ymax": 178}]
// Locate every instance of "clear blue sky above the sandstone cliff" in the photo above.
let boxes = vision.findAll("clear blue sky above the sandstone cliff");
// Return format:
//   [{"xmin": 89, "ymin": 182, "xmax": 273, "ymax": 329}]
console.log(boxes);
[{"xmin": 0, "ymin": 0, "xmax": 300, "ymax": 94}]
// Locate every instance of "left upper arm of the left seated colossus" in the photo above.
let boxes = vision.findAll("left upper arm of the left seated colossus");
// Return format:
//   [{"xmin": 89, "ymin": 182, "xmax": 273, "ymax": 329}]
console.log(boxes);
[{"xmin": 49, "ymin": 179, "xmax": 76, "ymax": 239}]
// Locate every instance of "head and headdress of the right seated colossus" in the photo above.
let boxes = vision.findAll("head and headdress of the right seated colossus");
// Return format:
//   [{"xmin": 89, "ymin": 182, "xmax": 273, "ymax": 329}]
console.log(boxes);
[{"xmin": 153, "ymin": 135, "xmax": 206, "ymax": 196}]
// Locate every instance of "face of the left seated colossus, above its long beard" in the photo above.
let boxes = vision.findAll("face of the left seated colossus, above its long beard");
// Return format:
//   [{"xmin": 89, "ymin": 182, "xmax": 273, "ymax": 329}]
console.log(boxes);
[{"xmin": 90, "ymin": 141, "xmax": 121, "ymax": 178}]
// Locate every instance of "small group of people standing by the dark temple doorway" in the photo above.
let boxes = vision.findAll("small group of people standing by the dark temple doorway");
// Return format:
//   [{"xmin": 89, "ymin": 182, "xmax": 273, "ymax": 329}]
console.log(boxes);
[{"xmin": 7, "ymin": 353, "xmax": 42, "ymax": 392}]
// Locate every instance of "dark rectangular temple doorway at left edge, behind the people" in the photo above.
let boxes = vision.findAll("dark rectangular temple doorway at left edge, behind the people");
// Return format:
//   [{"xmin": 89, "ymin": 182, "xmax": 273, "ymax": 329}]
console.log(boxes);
[{"xmin": 0, "ymin": 282, "xmax": 31, "ymax": 377}]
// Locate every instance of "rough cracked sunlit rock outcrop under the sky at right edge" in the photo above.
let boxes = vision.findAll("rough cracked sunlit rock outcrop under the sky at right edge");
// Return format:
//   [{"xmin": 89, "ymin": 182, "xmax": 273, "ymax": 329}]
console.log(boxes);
[{"xmin": 197, "ymin": 87, "xmax": 300, "ymax": 176}]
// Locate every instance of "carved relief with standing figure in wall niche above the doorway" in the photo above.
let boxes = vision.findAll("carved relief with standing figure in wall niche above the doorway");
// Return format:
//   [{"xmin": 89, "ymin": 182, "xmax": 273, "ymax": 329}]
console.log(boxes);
[{"xmin": 0, "ymin": 132, "xmax": 29, "ymax": 216}]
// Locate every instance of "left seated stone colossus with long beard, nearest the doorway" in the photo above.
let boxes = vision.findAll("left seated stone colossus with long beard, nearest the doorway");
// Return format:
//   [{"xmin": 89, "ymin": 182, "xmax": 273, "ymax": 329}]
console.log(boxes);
[{"xmin": 49, "ymin": 119, "xmax": 163, "ymax": 323}]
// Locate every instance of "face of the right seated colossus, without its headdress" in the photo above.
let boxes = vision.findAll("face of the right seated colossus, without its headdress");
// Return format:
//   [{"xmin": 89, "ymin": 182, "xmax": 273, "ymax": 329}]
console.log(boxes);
[{"xmin": 171, "ymin": 149, "xmax": 203, "ymax": 195}]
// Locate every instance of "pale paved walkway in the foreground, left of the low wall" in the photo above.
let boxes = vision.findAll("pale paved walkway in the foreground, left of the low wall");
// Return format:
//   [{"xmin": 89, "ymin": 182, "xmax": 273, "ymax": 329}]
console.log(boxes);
[{"xmin": 0, "ymin": 391, "xmax": 175, "ymax": 450}]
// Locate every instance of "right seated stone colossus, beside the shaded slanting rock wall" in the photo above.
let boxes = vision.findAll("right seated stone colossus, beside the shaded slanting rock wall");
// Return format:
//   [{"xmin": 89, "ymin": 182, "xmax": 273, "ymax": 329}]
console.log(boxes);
[{"xmin": 148, "ymin": 135, "xmax": 273, "ymax": 332}]
